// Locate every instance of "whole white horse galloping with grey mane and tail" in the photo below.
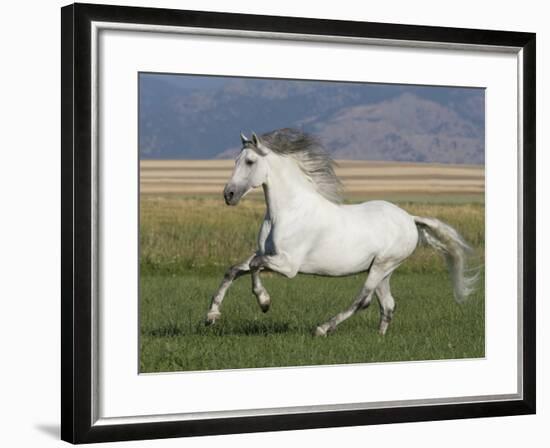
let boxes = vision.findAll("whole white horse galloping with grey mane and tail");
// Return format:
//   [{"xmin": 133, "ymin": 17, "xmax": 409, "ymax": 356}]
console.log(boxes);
[{"xmin": 206, "ymin": 129, "xmax": 477, "ymax": 336}]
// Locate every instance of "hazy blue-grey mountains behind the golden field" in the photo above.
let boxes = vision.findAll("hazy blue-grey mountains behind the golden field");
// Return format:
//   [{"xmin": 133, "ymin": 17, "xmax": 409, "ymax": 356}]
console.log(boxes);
[{"xmin": 139, "ymin": 76, "xmax": 484, "ymax": 164}]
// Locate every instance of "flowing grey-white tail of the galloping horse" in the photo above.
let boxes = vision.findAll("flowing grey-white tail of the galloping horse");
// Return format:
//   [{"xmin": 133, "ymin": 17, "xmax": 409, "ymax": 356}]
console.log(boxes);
[{"xmin": 413, "ymin": 216, "xmax": 479, "ymax": 303}]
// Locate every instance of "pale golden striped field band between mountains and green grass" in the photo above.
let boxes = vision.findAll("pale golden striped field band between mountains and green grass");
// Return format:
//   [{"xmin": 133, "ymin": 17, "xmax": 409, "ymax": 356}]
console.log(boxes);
[{"xmin": 140, "ymin": 160, "xmax": 485, "ymax": 196}]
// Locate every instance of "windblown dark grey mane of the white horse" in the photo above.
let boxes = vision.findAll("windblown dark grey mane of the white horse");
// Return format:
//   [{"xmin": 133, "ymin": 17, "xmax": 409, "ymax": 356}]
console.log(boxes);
[{"xmin": 260, "ymin": 128, "xmax": 343, "ymax": 203}]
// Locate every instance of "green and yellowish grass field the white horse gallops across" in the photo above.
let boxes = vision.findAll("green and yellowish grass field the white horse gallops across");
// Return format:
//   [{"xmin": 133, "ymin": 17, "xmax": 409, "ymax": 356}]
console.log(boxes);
[{"xmin": 140, "ymin": 195, "xmax": 485, "ymax": 372}]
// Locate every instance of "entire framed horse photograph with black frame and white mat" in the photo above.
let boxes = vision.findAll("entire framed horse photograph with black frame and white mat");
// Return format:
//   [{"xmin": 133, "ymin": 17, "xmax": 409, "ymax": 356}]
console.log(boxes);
[{"xmin": 61, "ymin": 4, "xmax": 536, "ymax": 443}]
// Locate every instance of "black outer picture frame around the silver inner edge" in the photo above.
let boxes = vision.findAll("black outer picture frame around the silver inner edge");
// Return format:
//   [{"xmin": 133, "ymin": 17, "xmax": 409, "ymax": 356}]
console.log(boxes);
[{"xmin": 61, "ymin": 4, "xmax": 536, "ymax": 443}]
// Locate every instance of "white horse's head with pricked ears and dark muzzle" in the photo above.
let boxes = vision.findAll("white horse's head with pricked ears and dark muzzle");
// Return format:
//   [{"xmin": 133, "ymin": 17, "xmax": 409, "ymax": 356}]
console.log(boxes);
[{"xmin": 223, "ymin": 133, "xmax": 269, "ymax": 205}]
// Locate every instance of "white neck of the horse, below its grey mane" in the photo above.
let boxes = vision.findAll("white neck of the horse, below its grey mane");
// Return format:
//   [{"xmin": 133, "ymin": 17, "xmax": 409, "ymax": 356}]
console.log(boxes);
[{"xmin": 263, "ymin": 157, "xmax": 328, "ymax": 222}]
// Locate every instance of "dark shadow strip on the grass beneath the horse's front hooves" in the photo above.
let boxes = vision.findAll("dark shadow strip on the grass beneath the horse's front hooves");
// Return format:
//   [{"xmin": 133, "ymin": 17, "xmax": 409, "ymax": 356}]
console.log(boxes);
[{"xmin": 143, "ymin": 320, "xmax": 300, "ymax": 338}]
